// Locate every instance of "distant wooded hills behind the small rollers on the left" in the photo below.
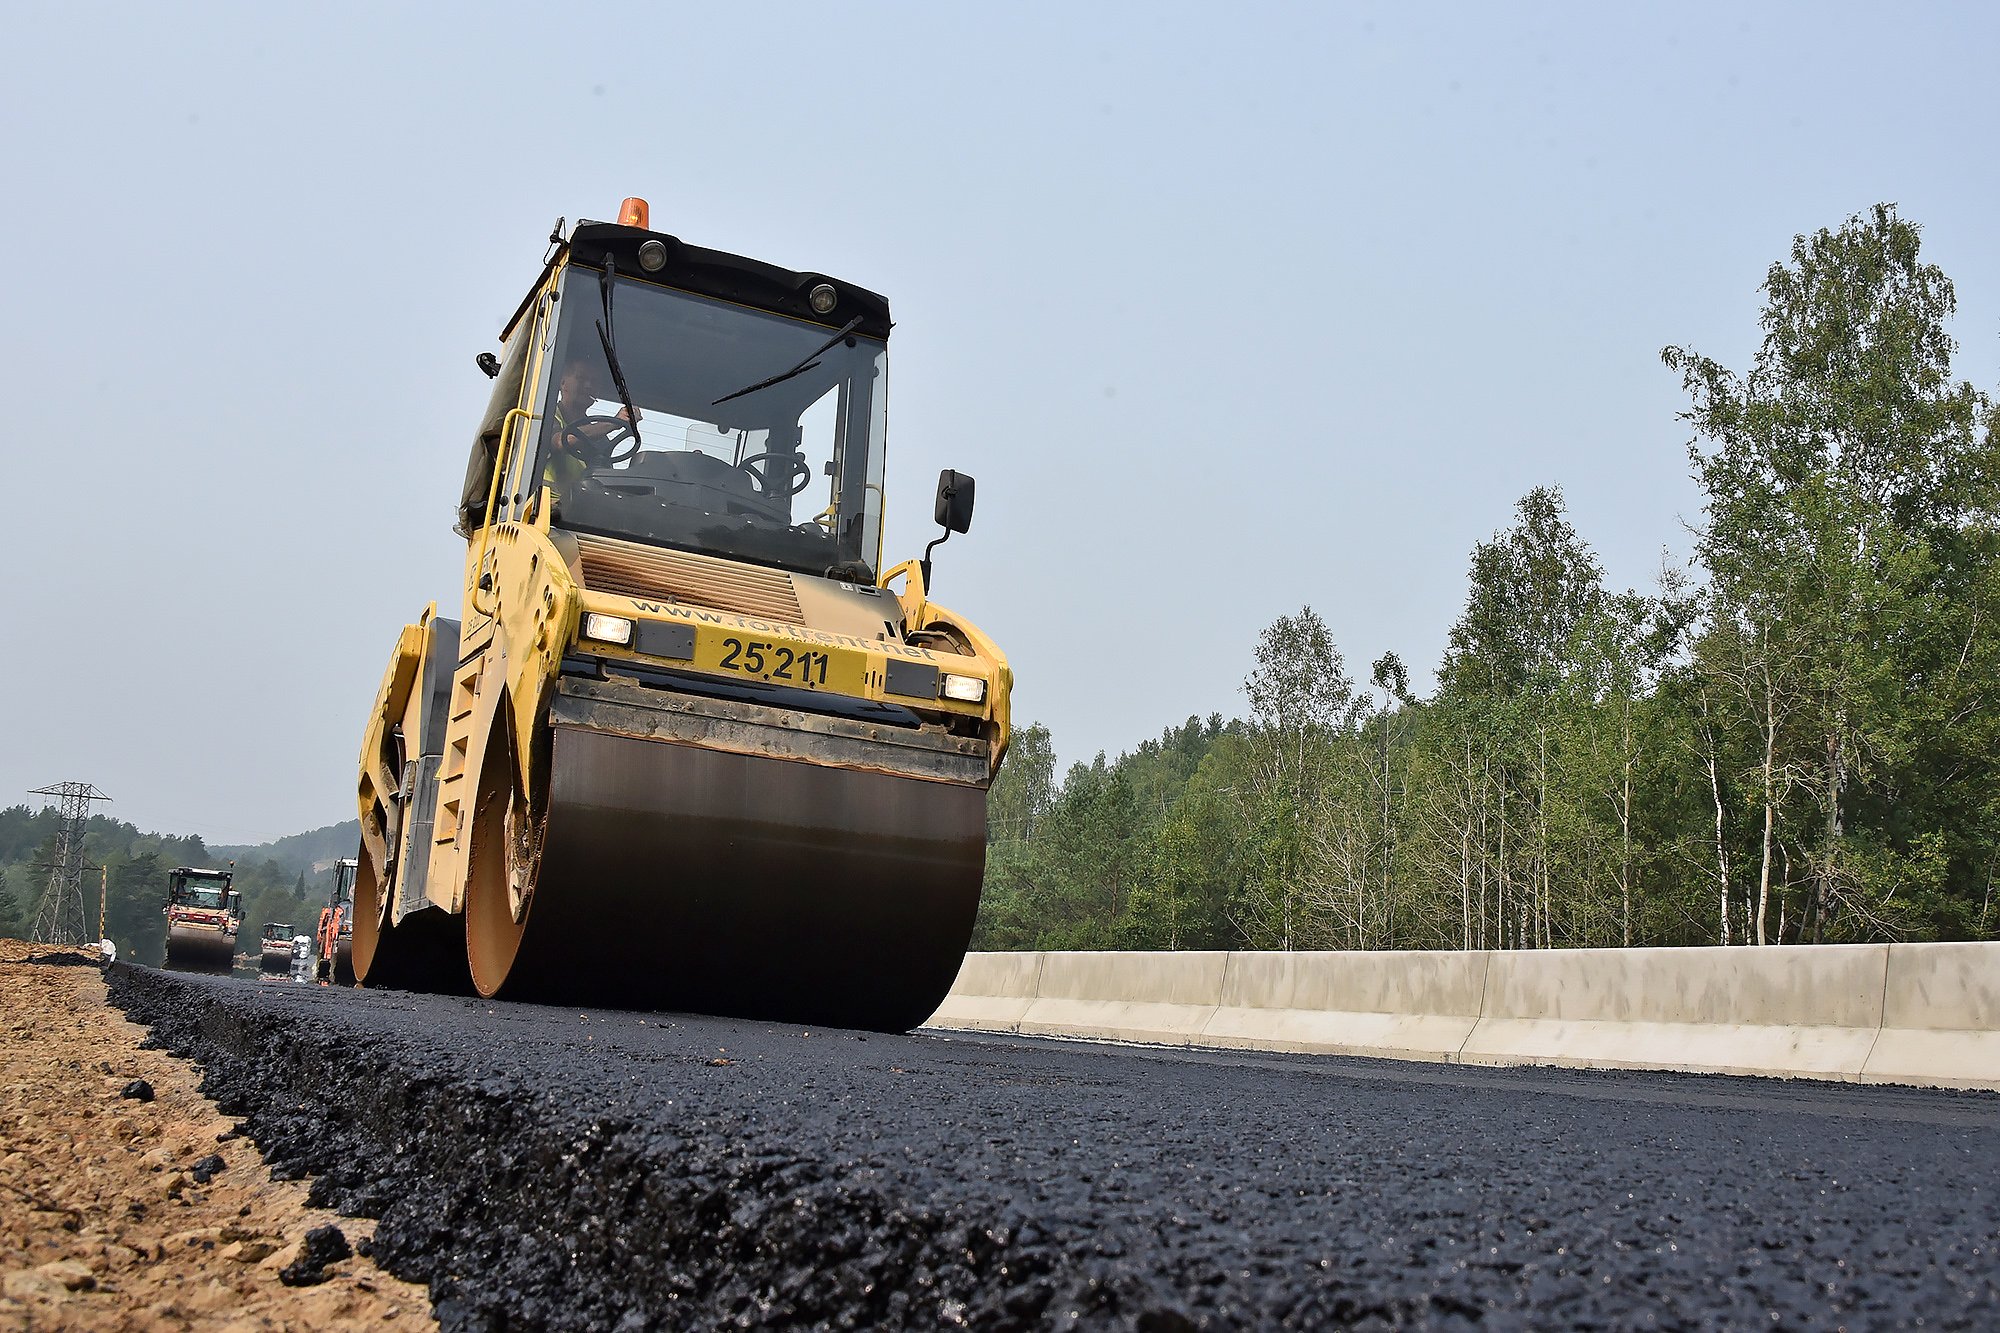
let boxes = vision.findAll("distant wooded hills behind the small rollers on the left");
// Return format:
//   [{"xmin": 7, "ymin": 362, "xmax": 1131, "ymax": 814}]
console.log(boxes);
[{"xmin": 0, "ymin": 805, "xmax": 360, "ymax": 965}]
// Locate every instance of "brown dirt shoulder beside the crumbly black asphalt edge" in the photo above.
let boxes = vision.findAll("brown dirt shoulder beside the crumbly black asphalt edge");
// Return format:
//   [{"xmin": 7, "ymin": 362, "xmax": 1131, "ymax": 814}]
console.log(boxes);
[{"xmin": 0, "ymin": 941, "xmax": 436, "ymax": 1333}]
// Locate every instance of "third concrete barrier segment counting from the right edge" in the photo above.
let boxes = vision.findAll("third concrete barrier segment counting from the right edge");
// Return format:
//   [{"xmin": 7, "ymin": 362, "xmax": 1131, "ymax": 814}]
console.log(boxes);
[{"xmin": 1196, "ymin": 953, "xmax": 1488, "ymax": 1061}]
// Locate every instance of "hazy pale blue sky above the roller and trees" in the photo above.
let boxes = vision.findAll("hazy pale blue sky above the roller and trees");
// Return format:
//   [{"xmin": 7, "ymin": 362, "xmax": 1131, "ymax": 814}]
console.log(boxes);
[{"xmin": 0, "ymin": 0, "xmax": 2000, "ymax": 843}]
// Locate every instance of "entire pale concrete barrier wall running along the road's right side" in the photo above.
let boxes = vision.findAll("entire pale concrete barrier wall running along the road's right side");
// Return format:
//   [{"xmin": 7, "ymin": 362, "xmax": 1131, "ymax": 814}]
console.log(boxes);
[{"xmin": 930, "ymin": 945, "xmax": 2000, "ymax": 1089}]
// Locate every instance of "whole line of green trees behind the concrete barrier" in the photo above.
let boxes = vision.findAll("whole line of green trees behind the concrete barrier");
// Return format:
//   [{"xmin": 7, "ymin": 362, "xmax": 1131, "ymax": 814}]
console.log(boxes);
[{"xmin": 974, "ymin": 204, "xmax": 2000, "ymax": 949}]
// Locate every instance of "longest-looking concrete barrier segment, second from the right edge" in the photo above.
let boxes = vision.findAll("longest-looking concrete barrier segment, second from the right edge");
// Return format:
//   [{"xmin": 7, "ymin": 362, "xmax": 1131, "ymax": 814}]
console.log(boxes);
[{"xmin": 1458, "ymin": 945, "xmax": 1888, "ymax": 1081}]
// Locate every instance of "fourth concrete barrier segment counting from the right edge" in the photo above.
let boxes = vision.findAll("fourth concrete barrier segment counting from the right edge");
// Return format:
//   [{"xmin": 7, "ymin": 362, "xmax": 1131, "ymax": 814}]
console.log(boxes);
[{"xmin": 1014, "ymin": 953, "xmax": 1230, "ymax": 1047}]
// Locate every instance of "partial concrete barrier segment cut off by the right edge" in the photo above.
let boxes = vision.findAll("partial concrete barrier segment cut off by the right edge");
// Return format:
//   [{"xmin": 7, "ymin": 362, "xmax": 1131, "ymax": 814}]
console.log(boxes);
[{"xmin": 1862, "ymin": 945, "xmax": 2000, "ymax": 1089}]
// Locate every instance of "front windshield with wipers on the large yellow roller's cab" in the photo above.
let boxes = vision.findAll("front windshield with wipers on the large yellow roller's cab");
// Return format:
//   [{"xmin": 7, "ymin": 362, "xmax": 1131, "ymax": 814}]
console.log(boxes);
[{"xmin": 516, "ymin": 266, "xmax": 888, "ymax": 582}]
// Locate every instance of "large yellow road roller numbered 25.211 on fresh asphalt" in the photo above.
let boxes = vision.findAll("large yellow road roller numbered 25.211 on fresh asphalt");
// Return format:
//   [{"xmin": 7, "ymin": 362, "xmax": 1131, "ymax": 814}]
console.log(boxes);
[{"xmin": 354, "ymin": 198, "xmax": 1012, "ymax": 1031}]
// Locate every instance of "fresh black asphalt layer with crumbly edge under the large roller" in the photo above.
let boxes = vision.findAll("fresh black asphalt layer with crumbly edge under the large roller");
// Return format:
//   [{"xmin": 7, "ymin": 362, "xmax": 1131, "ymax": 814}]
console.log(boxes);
[{"xmin": 110, "ymin": 967, "xmax": 2000, "ymax": 1331}]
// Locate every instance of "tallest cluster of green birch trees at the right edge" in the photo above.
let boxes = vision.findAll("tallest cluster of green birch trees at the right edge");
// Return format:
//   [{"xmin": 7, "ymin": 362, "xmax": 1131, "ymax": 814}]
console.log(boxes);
[{"xmin": 1664, "ymin": 204, "xmax": 2000, "ymax": 943}]
